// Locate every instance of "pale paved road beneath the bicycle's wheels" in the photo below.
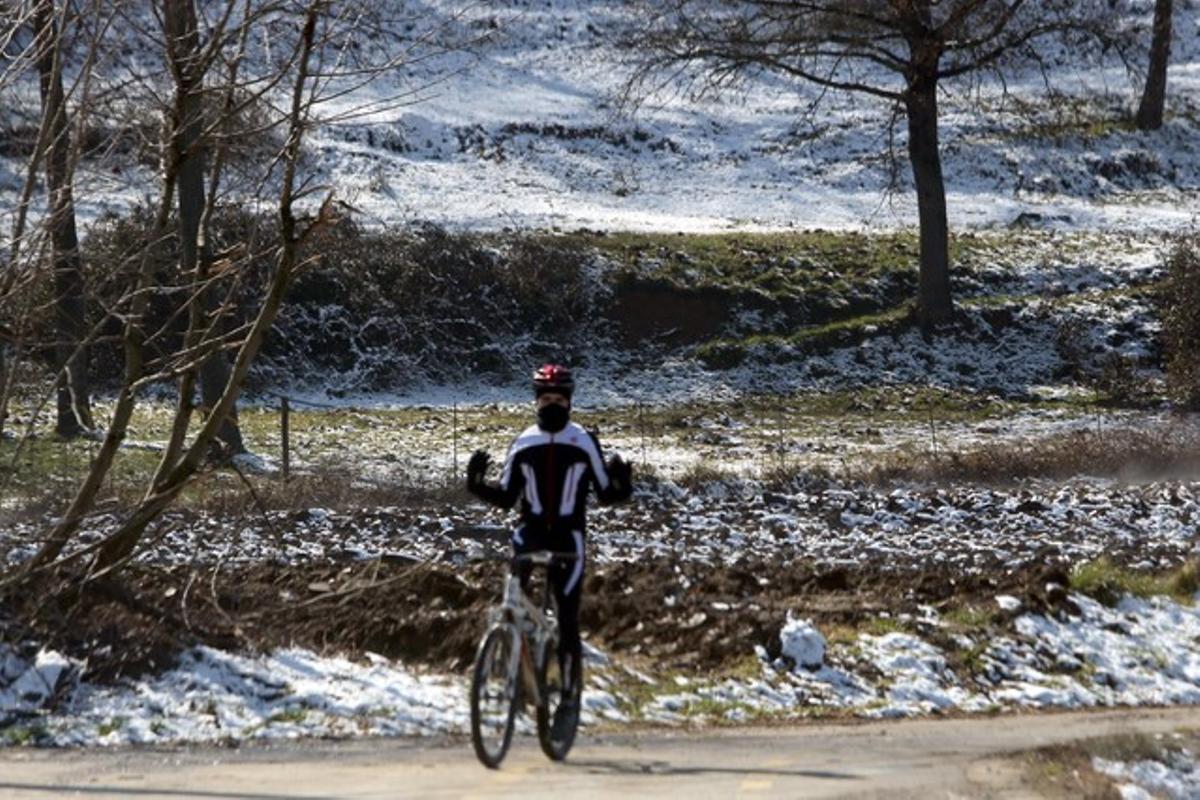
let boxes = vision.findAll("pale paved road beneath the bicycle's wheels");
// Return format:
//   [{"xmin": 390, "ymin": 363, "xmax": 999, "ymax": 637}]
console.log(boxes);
[{"xmin": 0, "ymin": 708, "xmax": 1200, "ymax": 800}]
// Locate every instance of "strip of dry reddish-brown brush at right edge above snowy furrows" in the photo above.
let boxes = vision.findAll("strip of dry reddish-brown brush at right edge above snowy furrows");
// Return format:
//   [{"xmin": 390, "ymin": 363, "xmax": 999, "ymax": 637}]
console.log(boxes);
[{"xmin": 865, "ymin": 423, "xmax": 1200, "ymax": 485}]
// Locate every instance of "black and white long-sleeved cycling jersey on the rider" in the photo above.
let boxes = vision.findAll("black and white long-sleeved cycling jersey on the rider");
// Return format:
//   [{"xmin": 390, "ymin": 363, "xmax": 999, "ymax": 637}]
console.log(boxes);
[{"xmin": 472, "ymin": 422, "xmax": 630, "ymax": 534}]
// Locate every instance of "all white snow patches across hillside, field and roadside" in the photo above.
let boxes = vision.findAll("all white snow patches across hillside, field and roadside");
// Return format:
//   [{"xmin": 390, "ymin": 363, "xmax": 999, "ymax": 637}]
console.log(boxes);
[{"xmin": 0, "ymin": 0, "xmax": 1200, "ymax": 753}]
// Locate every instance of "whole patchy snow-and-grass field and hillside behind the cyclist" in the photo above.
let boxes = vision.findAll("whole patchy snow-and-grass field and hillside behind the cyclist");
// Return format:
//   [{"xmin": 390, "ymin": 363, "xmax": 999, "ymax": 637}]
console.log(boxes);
[{"xmin": 0, "ymin": 0, "xmax": 1200, "ymax": 796}]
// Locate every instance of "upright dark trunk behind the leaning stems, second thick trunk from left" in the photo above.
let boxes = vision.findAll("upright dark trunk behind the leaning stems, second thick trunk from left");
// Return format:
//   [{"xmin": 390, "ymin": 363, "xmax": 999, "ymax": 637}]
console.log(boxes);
[{"xmin": 163, "ymin": 0, "xmax": 246, "ymax": 456}]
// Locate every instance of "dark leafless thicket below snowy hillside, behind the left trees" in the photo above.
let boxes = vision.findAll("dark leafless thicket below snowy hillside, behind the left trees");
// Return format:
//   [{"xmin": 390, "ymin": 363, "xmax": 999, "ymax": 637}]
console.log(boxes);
[{"xmin": 59, "ymin": 206, "xmax": 604, "ymax": 390}]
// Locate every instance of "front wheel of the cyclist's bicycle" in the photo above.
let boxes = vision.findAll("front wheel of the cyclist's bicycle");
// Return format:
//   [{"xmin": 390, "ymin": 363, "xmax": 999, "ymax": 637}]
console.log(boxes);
[{"xmin": 470, "ymin": 625, "xmax": 517, "ymax": 769}]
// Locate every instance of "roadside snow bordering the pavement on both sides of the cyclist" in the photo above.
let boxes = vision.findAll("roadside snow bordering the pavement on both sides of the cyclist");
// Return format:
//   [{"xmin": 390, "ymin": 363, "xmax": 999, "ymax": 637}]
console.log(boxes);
[{"xmin": 0, "ymin": 587, "xmax": 1200, "ymax": 743}]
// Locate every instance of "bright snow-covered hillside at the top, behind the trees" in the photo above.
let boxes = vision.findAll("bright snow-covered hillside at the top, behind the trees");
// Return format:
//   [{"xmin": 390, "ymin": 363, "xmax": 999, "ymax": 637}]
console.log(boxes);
[{"xmin": 0, "ymin": 0, "xmax": 1200, "ymax": 230}]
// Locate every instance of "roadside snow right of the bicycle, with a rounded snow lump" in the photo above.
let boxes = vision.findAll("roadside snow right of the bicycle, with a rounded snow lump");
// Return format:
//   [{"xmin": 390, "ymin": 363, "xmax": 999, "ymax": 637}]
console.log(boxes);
[{"xmin": 647, "ymin": 595, "xmax": 1200, "ymax": 721}]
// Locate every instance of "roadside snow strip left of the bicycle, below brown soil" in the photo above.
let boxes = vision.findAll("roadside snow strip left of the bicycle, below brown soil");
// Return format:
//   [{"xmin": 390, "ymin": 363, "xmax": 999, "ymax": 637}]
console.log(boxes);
[{"xmin": 0, "ymin": 648, "xmax": 468, "ymax": 745}]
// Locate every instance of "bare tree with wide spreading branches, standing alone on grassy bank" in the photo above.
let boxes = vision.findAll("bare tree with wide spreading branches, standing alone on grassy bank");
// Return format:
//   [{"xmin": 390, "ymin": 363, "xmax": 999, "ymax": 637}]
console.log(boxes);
[{"xmin": 626, "ymin": 0, "xmax": 1111, "ymax": 330}]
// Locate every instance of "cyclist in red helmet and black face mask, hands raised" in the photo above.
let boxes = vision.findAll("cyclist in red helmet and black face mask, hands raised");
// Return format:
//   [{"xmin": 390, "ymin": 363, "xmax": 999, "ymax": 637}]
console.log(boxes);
[{"xmin": 467, "ymin": 363, "xmax": 632, "ymax": 722}]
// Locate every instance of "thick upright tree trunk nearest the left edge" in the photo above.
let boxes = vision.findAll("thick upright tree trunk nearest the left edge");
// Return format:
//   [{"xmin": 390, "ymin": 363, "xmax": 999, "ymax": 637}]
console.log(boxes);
[{"xmin": 36, "ymin": 0, "xmax": 95, "ymax": 437}]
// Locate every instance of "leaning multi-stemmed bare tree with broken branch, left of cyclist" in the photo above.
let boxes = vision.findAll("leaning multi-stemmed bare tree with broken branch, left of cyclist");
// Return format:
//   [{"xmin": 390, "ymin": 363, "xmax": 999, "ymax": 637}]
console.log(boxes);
[{"xmin": 7, "ymin": 0, "xmax": 477, "ymax": 587}]
